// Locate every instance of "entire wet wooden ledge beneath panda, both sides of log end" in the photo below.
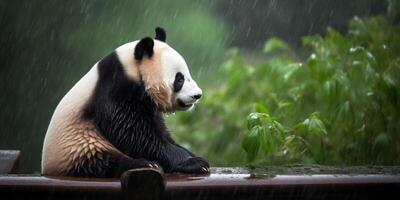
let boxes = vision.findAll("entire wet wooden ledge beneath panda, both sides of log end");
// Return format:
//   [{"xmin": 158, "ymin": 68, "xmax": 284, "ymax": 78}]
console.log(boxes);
[{"xmin": 0, "ymin": 167, "xmax": 400, "ymax": 200}]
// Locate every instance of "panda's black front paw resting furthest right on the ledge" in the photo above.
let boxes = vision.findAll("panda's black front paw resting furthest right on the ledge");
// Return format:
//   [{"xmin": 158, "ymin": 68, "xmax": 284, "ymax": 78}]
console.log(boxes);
[{"xmin": 173, "ymin": 157, "xmax": 210, "ymax": 174}]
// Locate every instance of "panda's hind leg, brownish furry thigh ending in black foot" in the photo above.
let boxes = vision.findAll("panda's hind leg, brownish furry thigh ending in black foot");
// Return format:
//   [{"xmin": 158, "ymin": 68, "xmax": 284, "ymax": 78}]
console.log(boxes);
[{"xmin": 61, "ymin": 128, "xmax": 160, "ymax": 178}]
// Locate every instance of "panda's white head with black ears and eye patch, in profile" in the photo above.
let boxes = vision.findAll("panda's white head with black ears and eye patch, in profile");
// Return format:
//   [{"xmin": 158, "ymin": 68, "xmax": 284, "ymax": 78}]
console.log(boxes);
[{"xmin": 117, "ymin": 28, "xmax": 202, "ymax": 112}]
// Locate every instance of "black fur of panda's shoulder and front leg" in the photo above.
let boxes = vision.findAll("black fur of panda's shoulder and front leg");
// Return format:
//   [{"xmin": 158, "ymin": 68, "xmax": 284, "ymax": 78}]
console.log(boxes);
[{"xmin": 83, "ymin": 52, "xmax": 209, "ymax": 177}]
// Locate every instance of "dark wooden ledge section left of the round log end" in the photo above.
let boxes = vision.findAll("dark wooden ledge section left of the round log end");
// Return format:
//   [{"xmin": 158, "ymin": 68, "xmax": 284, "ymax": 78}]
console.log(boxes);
[{"xmin": 0, "ymin": 175, "xmax": 123, "ymax": 200}]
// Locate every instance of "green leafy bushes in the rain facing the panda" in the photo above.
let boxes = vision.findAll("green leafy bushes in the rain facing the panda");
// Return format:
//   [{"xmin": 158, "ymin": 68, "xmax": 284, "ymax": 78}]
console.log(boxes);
[{"xmin": 169, "ymin": 17, "xmax": 400, "ymax": 166}]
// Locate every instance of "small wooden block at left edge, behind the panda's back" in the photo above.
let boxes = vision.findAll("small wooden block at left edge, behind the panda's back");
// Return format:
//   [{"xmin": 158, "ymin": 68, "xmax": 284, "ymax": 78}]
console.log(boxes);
[{"xmin": 0, "ymin": 150, "xmax": 20, "ymax": 174}]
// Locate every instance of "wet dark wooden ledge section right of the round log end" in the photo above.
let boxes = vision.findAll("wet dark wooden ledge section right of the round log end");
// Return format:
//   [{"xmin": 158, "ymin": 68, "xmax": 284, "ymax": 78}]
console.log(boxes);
[{"xmin": 163, "ymin": 174, "xmax": 400, "ymax": 200}]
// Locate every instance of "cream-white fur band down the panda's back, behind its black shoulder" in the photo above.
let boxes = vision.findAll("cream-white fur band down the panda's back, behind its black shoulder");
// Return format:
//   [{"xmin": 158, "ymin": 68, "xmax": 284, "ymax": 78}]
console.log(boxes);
[{"xmin": 42, "ymin": 64, "xmax": 98, "ymax": 174}]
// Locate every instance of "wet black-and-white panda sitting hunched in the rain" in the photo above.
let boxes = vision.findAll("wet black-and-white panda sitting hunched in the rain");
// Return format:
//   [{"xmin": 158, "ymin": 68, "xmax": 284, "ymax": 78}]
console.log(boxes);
[{"xmin": 41, "ymin": 27, "xmax": 210, "ymax": 177}]
